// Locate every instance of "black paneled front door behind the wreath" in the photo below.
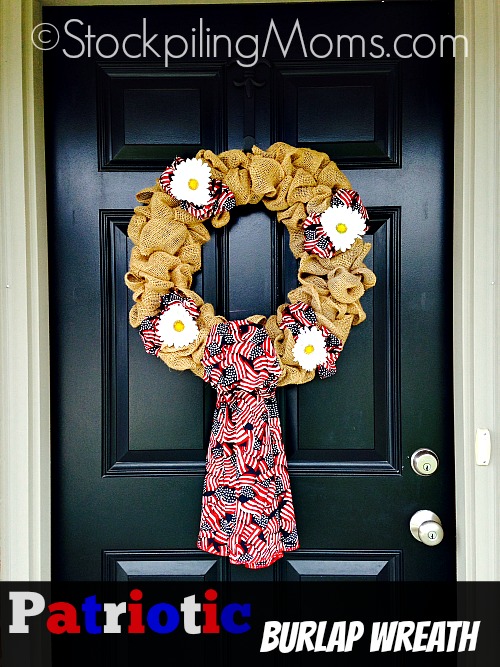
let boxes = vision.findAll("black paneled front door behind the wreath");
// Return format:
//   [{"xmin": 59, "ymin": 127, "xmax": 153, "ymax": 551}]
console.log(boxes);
[{"xmin": 44, "ymin": 2, "xmax": 455, "ymax": 581}]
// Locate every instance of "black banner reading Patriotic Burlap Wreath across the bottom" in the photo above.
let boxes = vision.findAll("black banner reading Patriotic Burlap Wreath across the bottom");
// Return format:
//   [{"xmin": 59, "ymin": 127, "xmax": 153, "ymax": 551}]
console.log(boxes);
[{"xmin": 0, "ymin": 580, "xmax": 500, "ymax": 667}]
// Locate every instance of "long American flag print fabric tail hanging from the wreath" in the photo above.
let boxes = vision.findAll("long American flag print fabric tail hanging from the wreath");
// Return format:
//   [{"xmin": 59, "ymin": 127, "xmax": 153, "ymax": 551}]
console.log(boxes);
[{"xmin": 197, "ymin": 319, "xmax": 299, "ymax": 569}]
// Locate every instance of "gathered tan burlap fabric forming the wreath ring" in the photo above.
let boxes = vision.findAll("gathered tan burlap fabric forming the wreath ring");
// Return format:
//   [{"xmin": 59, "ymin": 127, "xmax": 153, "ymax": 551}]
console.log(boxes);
[{"xmin": 125, "ymin": 142, "xmax": 376, "ymax": 385}]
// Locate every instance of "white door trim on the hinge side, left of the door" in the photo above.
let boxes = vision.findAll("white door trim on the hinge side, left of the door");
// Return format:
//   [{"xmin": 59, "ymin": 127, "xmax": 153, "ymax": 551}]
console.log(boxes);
[{"xmin": 0, "ymin": 0, "xmax": 50, "ymax": 581}]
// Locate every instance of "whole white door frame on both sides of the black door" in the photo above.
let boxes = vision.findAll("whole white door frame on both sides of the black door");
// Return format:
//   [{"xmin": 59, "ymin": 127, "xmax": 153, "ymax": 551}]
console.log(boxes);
[{"xmin": 0, "ymin": 0, "xmax": 500, "ymax": 581}]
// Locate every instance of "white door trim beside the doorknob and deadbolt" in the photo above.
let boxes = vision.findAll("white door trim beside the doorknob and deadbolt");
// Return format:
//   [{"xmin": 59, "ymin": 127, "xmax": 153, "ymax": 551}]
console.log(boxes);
[{"xmin": 453, "ymin": 0, "xmax": 500, "ymax": 581}]
